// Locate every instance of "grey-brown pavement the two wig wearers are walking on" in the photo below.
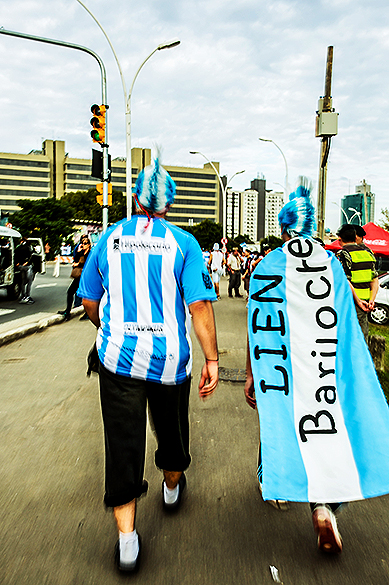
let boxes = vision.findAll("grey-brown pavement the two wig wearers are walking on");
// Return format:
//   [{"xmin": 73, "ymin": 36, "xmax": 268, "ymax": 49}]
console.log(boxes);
[{"xmin": 0, "ymin": 282, "xmax": 389, "ymax": 585}]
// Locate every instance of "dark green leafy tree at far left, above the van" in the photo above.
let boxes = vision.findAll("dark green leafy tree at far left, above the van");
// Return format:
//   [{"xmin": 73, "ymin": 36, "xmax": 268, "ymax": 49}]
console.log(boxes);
[{"xmin": 9, "ymin": 198, "xmax": 73, "ymax": 256}]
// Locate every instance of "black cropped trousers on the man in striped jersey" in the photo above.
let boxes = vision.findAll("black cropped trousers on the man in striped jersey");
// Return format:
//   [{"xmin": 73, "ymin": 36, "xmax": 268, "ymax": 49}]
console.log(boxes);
[{"xmin": 99, "ymin": 363, "xmax": 191, "ymax": 506}]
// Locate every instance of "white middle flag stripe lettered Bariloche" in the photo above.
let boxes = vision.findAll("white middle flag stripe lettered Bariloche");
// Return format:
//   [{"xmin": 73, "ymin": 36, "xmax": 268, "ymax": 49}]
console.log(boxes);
[{"xmin": 285, "ymin": 246, "xmax": 363, "ymax": 502}]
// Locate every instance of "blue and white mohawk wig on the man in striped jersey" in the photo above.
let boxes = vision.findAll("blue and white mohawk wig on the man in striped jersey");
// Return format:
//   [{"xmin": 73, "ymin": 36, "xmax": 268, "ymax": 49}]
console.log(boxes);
[{"xmin": 134, "ymin": 156, "xmax": 176, "ymax": 213}]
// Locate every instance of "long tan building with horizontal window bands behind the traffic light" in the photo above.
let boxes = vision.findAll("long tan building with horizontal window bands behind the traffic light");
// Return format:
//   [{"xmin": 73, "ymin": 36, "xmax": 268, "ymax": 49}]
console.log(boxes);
[{"xmin": 0, "ymin": 140, "xmax": 220, "ymax": 227}]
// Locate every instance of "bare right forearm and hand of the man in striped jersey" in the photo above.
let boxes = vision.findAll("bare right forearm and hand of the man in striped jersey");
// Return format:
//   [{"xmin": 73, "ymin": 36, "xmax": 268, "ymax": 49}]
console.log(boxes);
[{"xmin": 189, "ymin": 301, "xmax": 219, "ymax": 399}]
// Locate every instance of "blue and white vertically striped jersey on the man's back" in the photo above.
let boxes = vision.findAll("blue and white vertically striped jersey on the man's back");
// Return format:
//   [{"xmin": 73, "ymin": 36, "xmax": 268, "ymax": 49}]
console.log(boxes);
[{"xmin": 77, "ymin": 216, "xmax": 216, "ymax": 384}]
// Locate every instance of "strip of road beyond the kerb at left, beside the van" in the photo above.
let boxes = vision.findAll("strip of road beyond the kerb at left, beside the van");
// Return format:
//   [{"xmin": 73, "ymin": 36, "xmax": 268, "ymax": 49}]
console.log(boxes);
[{"xmin": 0, "ymin": 264, "xmax": 71, "ymax": 325}]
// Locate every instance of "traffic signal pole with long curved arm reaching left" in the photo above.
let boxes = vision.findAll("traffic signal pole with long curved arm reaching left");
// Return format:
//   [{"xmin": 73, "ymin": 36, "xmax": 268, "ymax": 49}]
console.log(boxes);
[{"xmin": 0, "ymin": 27, "xmax": 109, "ymax": 232}]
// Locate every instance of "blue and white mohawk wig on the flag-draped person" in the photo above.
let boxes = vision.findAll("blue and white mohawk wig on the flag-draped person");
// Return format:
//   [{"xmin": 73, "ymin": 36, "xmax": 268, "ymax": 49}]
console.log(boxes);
[{"xmin": 278, "ymin": 177, "xmax": 316, "ymax": 237}]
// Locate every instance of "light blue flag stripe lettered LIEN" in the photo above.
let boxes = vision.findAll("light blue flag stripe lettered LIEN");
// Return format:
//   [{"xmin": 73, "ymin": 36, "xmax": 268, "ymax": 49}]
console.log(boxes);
[{"xmin": 248, "ymin": 248, "xmax": 308, "ymax": 502}]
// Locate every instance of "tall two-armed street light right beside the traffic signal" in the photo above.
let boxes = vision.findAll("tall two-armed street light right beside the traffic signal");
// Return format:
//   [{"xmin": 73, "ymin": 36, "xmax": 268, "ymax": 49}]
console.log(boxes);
[{"xmin": 77, "ymin": 0, "xmax": 181, "ymax": 219}]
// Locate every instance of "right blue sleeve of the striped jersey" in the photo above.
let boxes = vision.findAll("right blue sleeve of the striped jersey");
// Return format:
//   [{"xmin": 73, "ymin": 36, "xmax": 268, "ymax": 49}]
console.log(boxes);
[{"xmin": 181, "ymin": 238, "xmax": 217, "ymax": 305}]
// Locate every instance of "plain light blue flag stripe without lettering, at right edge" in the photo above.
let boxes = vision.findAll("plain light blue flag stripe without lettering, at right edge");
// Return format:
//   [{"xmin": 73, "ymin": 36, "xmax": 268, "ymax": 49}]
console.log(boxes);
[{"xmin": 332, "ymin": 257, "xmax": 389, "ymax": 498}]
